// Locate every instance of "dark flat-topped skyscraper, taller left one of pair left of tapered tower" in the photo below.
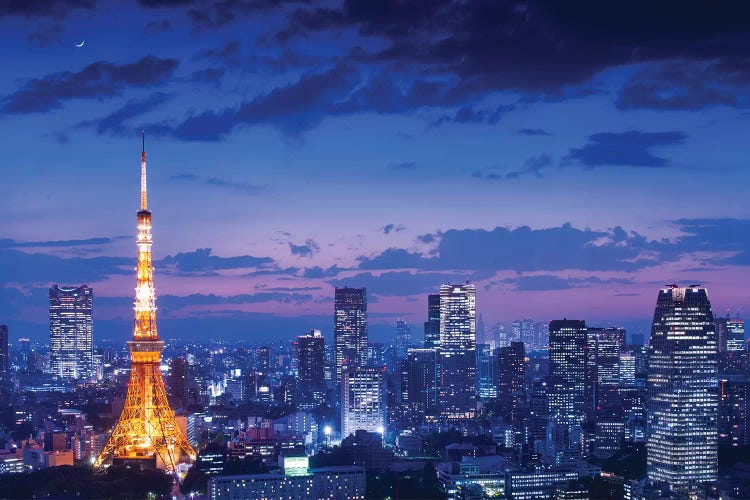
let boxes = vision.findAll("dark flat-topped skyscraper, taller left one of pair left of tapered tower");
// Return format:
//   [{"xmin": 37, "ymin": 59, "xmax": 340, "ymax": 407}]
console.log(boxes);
[{"xmin": 547, "ymin": 319, "xmax": 587, "ymax": 454}]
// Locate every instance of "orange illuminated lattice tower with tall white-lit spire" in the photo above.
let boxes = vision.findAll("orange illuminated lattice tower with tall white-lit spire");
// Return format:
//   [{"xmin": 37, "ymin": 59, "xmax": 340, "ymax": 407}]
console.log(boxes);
[{"xmin": 95, "ymin": 136, "xmax": 195, "ymax": 472}]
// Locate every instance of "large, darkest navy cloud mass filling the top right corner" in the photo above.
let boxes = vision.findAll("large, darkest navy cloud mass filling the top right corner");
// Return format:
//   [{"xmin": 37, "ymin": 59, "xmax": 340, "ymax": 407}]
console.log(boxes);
[{"xmin": 276, "ymin": 0, "xmax": 750, "ymax": 93}]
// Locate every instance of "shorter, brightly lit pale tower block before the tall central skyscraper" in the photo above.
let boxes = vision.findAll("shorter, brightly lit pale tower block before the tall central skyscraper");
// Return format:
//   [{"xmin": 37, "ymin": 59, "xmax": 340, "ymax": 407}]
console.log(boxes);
[{"xmin": 341, "ymin": 367, "xmax": 386, "ymax": 438}]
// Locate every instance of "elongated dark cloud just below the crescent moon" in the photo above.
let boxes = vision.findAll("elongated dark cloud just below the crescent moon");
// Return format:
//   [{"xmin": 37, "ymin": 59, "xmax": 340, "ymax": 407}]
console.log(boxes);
[{"xmin": 0, "ymin": 56, "xmax": 179, "ymax": 114}]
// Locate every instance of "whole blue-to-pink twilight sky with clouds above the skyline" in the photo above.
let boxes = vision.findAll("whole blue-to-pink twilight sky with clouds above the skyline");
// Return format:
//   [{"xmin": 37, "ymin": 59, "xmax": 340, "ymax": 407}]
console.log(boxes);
[{"xmin": 0, "ymin": 0, "xmax": 750, "ymax": 342}]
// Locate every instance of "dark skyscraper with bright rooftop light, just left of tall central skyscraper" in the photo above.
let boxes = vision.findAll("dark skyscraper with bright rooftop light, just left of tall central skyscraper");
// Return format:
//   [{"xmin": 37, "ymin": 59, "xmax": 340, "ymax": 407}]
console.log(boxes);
[{"xmin": 297, "ymin": 330, "xmax": 326, "ymax": 409}]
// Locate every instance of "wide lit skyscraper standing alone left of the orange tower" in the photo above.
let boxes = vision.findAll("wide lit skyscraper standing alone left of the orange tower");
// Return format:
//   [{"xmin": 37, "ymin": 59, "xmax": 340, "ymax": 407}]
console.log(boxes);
[{"xmin": 49, "ymin": 285, "xmax": 94, "ymax": 379}]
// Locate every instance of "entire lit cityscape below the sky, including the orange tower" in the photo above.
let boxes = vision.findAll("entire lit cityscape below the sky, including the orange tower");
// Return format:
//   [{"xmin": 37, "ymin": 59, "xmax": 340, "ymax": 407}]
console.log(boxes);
[{"xmin": 0, "ymin": 146, "xmax": 750, "ymax": 500}]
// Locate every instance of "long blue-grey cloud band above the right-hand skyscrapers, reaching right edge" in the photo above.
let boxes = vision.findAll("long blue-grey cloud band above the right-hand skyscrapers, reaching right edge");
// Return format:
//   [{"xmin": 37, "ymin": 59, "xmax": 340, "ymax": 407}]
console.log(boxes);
[{"xmin": 359, "ymin": 219, "xmax": 750, "ymax": 279}]
